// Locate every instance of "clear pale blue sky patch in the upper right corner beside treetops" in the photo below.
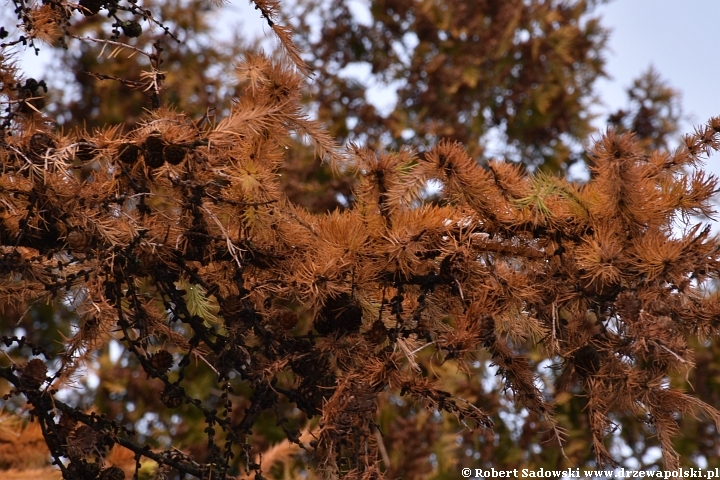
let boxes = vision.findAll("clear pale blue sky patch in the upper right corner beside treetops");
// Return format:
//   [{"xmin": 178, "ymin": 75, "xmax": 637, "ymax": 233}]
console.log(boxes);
[{"xmin": 598, "ymin": 0, "xmax": 720, "ymax": 132}]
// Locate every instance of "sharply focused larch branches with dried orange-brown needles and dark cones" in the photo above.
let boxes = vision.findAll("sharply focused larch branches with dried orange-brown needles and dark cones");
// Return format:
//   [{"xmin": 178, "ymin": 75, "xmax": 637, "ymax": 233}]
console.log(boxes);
[{"xmin": 0, "ymin": 2, "xmax": 720, "ymax": 478}]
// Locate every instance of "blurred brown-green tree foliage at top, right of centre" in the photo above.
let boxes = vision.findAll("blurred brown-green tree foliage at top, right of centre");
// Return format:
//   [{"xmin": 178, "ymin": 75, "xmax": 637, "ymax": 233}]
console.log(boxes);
[{"xmin": 295, "ymin": 0, "xmax": 607, "ymax": 170}]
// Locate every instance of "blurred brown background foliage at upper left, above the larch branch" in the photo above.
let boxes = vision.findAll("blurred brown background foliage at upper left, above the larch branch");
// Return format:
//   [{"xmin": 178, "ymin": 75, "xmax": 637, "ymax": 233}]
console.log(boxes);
[{"xmin": 43, "ymin": 0, "xmax": 249, "ymax": 129}]
